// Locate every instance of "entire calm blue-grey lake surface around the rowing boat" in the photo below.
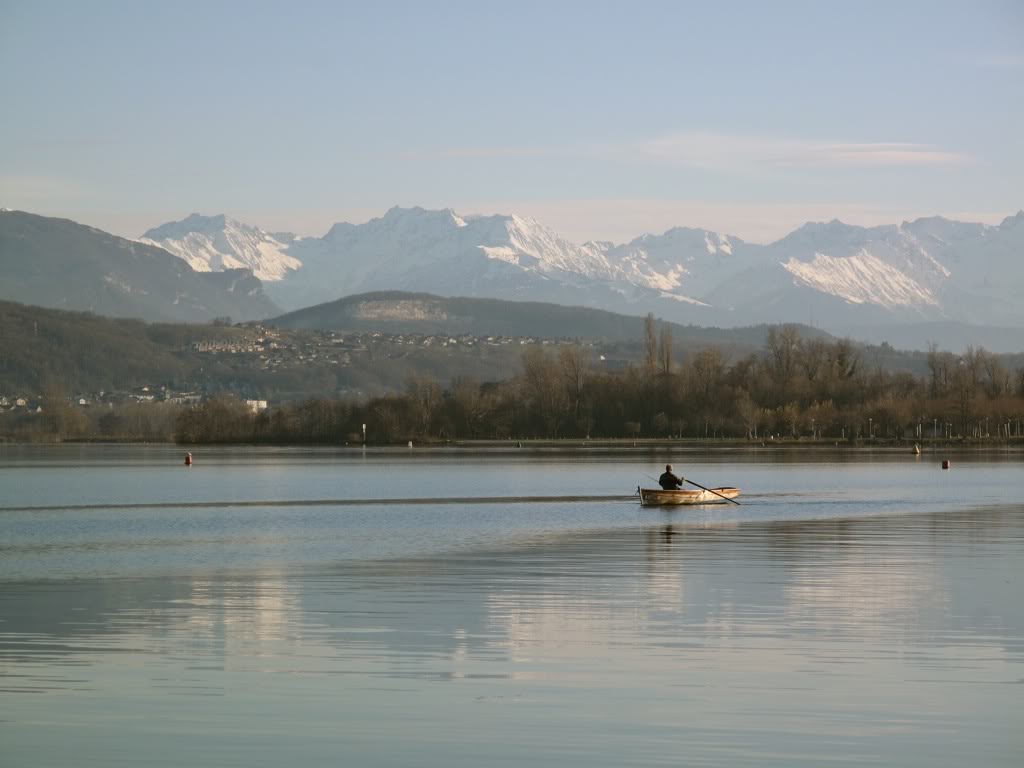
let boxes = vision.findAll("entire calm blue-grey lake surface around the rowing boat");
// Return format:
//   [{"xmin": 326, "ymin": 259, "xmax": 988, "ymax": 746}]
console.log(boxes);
[{"xmin": 0, "ymin": 445, "xmax": 1024, "ymax": 768}]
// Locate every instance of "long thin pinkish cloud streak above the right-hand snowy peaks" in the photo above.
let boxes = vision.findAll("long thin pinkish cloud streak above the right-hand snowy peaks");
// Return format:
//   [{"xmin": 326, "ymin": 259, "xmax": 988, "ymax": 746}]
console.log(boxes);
[{"xmin": 636, "ymin": 133, "xmax": 969, "ymax": 171}]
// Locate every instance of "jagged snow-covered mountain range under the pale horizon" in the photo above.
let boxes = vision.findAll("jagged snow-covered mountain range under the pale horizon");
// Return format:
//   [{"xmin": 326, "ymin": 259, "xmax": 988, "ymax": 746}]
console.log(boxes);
[{"xmin": 146, "ymin": 208, "xmax": 1024, "ymax": 333}]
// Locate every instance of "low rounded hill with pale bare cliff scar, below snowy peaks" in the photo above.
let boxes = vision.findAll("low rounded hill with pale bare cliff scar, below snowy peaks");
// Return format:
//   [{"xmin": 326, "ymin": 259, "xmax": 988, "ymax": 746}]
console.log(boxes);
[{"xmin": 266, "ymin": 291, "xmax": 827, "ymax": 348}]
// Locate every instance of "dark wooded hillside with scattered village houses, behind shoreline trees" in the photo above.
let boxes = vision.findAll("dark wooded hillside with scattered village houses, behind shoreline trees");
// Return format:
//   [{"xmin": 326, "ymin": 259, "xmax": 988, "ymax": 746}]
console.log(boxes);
[{"xmin": 0, "ymin": 294, "xmax": 1024, "ymax": 399}]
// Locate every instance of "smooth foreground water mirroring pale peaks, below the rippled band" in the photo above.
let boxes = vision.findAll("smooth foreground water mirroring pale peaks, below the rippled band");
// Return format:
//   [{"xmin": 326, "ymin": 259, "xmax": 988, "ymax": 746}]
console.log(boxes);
[{"xmin": 0, "ymin": 506, "xmax": 1024, "ymax": 765}]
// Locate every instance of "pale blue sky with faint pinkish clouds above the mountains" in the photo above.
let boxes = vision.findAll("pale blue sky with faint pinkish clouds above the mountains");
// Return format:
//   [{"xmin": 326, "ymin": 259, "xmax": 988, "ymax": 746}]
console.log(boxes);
[{"xmin": 0, "ymin": 0, "xmax": 1024, "ymax": 242}]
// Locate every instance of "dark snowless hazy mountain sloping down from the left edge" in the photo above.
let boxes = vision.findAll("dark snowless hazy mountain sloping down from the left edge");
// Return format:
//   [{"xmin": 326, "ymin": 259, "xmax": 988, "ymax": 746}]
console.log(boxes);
[{"xmin": 0, "ymin": 211, "xmax": 278, "ymax": 322}]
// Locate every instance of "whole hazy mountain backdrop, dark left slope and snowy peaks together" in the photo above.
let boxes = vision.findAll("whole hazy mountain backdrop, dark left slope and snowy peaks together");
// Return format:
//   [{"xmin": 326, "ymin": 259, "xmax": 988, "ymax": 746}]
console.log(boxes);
[{"xmin": 0, "ymin": 202, "xmax": 1024, "ymax": 349}]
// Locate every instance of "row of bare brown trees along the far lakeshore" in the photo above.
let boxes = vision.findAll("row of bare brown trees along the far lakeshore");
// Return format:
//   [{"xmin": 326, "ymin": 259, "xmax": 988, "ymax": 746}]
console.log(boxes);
[{"xmin": 6, "ymin": 317, "xmax": 1024, "ymax": 445}]
